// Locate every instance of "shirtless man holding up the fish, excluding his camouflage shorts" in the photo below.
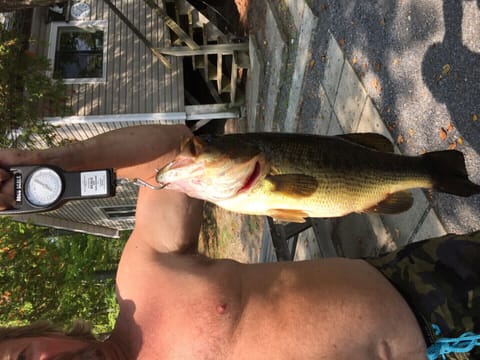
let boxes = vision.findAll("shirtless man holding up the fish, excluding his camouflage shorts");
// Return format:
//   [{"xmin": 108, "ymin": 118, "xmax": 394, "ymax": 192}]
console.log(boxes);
[{"xmin": 0, "ymin": 125, "xmax": 480, "ymax": 360}]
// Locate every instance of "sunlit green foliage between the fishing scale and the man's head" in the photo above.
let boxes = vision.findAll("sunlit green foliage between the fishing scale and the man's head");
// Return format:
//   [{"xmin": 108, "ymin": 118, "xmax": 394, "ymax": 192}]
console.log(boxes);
[{"xmin": 0, "ymin": 217, "xmax": 125, "ymax": 333}]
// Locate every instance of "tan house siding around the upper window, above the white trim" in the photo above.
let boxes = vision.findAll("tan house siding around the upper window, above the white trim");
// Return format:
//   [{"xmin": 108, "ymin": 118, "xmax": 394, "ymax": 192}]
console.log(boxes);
[{"xmin": 32, "ymin": 0, "xmax": 185, "ymax": 116}]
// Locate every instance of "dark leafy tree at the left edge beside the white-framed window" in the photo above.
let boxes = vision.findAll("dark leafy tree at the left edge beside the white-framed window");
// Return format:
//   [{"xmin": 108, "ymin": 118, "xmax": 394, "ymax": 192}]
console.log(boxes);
[{"xmin": 0, "ymin": 21, "xmax": 70, "ymax": 147}]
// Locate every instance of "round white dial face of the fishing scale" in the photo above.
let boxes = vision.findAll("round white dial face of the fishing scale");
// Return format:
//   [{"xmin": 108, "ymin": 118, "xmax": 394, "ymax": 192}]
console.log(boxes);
[{"xmin": 25, "ymin": 168, "xmax": 62, "ymax": 206}]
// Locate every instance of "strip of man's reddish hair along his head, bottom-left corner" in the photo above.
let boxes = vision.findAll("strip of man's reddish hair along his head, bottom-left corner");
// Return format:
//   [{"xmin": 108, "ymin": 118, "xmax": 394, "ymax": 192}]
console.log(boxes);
[{"xmin": 0, "ymin": 320, "xmax": 96, "ymax": 342}]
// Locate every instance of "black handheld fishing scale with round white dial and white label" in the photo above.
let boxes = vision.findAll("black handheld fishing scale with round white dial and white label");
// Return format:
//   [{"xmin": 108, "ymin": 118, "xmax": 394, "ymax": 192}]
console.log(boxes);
[{"xmin": 0, "ymin": 165, "xmax": 116, "ymax": 215}]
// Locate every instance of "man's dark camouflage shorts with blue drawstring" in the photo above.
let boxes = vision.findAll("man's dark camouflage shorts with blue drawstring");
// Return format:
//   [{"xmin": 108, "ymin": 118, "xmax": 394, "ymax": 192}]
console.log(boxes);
[{"xmin": 366, "ymin": 231, "xmax": 480, "ymax": 359}]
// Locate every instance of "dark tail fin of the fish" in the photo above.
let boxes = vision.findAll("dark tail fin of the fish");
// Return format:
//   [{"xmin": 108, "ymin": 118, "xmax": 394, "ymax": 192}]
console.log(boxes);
[{"xmin": 422, "ymin": 150, "xmax": 480, "ymax": 197}]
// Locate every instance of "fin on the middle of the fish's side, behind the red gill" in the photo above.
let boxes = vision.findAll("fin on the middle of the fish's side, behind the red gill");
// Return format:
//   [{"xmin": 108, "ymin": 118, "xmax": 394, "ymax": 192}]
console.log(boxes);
[{"xmin": 265, "ymin": 174, "xmax": 318, "ymax": 197}]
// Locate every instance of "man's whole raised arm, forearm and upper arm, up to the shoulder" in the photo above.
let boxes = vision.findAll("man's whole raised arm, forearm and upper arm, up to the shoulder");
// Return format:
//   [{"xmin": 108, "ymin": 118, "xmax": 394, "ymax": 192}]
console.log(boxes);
[{"xmin": 0, "ymin": 125, "xmax": 202, "ymax": 252}]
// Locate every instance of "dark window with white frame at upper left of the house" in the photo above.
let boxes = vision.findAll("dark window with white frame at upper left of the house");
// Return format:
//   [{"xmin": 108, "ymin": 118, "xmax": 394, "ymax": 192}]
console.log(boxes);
[{"xmin": 49, "ymin": 21, "xmax": 106, "ymax": 83}]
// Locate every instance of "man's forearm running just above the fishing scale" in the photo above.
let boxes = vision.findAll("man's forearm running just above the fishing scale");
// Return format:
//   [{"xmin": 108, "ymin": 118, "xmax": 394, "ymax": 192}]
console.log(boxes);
[{"xmin": 0, "ymin": 125, "xmax": 191, "ymax": 177}]
